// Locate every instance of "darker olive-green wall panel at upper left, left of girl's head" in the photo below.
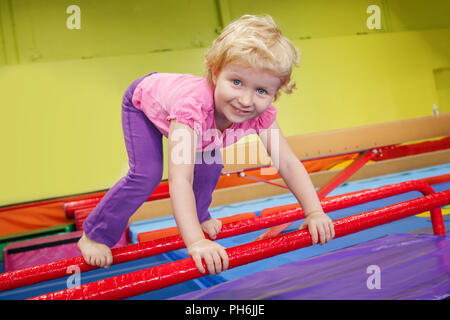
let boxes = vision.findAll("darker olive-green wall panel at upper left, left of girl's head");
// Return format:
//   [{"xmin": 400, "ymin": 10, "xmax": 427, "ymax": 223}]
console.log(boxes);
[{"xmin": 5, "ymin": 0, "xmax": 218, "ymax": 63}]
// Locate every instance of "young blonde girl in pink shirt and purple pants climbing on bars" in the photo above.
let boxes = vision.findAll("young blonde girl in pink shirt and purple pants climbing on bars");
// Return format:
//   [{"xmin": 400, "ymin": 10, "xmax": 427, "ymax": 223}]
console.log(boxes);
[{"xmin": 78, "ymin": 15, "xmax": 334, "ymax": 274}]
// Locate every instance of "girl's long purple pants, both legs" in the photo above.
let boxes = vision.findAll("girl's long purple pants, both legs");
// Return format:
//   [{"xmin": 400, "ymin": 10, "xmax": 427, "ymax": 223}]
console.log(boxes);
[{"xmin": 83, "ymin": 74, "xmax": 223, "ymax": 247}]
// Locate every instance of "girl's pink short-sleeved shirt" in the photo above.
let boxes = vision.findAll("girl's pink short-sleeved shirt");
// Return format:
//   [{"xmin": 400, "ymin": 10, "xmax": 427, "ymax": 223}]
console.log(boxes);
[{"xmin": 132, "ymin": 73, "xmax": 277, "ymax": 151}]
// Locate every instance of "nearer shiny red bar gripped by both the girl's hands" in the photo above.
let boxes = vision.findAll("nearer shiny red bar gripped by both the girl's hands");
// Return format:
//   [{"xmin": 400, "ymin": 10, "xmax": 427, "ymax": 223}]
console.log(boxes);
[{"xmin": 29, "ymin": 190, "xmax": 450, "ymax": 300}]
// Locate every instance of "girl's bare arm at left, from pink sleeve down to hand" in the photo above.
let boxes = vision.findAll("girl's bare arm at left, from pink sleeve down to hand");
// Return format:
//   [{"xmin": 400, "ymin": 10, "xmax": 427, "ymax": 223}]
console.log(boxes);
[{"xmin": 168, "ymin": 120, "xmax": 228, "ymax": 274}]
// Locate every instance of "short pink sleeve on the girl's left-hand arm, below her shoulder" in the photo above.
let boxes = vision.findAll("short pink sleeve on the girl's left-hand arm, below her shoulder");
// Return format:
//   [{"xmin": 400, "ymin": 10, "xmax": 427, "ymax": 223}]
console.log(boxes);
[{"xmin": 166, "ymin": 97, "xmax": 204, "ymax": 135}]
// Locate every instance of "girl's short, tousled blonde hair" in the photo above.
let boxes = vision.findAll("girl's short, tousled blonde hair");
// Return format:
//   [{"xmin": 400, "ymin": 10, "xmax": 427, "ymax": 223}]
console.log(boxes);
[{"xmin": 205, "ymin": 15, "xmax": 300, "ymax": 100}]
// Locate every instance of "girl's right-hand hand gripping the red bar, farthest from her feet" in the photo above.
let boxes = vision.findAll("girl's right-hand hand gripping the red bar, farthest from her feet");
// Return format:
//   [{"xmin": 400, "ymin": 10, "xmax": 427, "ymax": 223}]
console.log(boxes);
[{"xmin": 300, "ymin": 211, "xmax": 335, "ymax": 245}]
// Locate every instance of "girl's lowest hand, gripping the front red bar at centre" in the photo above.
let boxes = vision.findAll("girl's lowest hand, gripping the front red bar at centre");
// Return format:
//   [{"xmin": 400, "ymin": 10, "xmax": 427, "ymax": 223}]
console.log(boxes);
[{"xmin": 187, "ymin": 239, "xmax": 228, "ymax": 275}]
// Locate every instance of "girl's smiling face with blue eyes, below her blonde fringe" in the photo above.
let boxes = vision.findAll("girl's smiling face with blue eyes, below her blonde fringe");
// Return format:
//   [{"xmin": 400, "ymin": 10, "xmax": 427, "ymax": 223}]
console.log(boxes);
[{"xmin": 213, "ymin": 63, "xmax": 281, "ymax": 131}]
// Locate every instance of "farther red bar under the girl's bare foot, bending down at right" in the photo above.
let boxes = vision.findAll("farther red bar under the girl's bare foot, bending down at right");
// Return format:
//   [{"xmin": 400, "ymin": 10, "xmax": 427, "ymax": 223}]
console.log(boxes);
[{"xmin": 0, "ymin": 180, "xmax": 445, "ymax": 291}]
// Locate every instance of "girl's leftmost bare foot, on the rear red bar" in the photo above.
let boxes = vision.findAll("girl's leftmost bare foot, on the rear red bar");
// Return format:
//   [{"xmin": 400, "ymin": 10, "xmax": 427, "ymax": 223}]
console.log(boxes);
[{"xmin": 78, "ymin": 232, "xmax": 113, "ymax": 269}]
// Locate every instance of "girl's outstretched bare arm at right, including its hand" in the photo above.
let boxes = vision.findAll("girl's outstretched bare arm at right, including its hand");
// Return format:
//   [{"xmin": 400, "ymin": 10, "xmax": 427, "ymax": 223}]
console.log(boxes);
[{"xmin": 259, "ymin": 121, "xmax": 334, "ymax": 244}]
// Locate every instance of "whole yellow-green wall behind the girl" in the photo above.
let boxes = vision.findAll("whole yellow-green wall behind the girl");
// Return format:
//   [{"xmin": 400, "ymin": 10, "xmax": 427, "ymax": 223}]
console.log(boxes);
[{"xmin": 0, "ymin": 0, "xmax": 450, "ymax": 205}]
